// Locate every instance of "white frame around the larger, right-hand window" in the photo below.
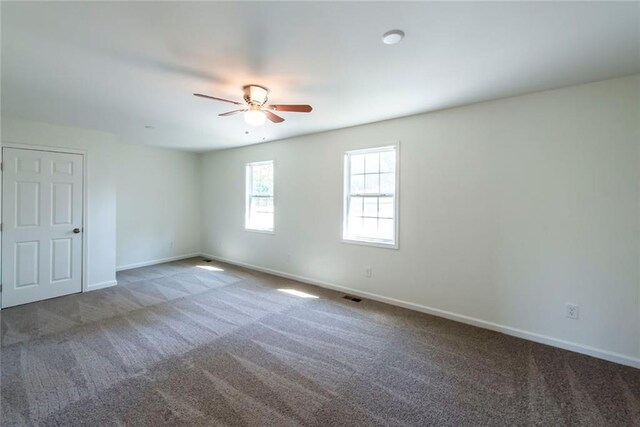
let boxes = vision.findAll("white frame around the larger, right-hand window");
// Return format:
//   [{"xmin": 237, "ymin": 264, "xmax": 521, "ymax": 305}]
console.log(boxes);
[{"xmin": 340, "ymin": 145, "xmax": 400, "ymax": 249}]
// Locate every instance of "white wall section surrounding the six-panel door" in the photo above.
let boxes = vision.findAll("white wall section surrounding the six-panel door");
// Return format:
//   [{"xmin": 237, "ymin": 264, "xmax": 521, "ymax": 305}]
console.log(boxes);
[{"xmin": 1, "ymin": 117, "xmax": 117, "ymax": 289}]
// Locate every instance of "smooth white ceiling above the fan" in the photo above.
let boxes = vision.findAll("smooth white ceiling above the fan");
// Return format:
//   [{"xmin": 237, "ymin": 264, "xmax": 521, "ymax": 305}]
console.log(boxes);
[{"xmin": 1, "ymin": 2, "xmax": 640, "ymax": 151}]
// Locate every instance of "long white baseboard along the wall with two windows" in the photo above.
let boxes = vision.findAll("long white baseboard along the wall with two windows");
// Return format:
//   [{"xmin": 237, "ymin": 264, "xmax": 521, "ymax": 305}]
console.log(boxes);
[{"xmin": 200, "ymin": 253, "xmax": 640, "ymax": 369}]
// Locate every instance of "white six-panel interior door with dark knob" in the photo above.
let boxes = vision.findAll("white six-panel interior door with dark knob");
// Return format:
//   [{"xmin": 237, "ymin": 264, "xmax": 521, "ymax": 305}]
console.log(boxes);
[{"xmin": 2, "ymin": 148, "xmax": 83, "ymax": 307}]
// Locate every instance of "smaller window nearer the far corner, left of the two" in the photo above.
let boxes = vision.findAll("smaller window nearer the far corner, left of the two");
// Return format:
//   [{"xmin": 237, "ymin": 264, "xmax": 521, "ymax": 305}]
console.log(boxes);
[{"xmin": 245, "ymin": 160, "xmax": 273, "ymax": 232}]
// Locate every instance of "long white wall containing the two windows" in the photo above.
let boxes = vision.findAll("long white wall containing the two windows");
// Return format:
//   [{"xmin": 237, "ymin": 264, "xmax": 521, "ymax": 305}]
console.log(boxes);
[{"xmin": 201, "ymin": 76, "xmax": 640, "ymax": 367}]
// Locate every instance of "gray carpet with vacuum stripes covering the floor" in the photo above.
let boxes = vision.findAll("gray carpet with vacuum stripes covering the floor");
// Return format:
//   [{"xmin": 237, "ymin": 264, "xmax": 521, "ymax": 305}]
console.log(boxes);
[{"xmin": 1, "ymin": 259, "xmax": 640, "ymax": 426}]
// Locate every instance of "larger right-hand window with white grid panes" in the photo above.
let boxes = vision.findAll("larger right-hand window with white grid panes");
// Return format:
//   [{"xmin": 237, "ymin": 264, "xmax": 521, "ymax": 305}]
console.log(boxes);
[{"xmin": 342, "ymin": 145, "xmax": 398, "ymax": 247}]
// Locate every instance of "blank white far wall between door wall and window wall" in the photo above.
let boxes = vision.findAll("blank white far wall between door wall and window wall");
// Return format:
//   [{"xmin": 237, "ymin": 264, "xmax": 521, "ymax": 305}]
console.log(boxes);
[{"xmin": 116, "ymin": 144, "xmax": 200, "ymax": 269}]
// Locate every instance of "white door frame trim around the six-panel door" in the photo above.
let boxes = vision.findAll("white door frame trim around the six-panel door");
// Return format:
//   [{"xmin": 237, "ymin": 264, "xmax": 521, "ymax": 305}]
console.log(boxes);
[{"xmin": 0, "ymin": 142, "xmax": 89, "ymax": 307}]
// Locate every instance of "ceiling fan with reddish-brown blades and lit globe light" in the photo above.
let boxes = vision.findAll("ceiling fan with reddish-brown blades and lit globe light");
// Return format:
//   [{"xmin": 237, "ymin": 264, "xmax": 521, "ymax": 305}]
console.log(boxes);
[{"xmin": 194, "ymin": 85, "xmax": 312, "ymax": 126}]
